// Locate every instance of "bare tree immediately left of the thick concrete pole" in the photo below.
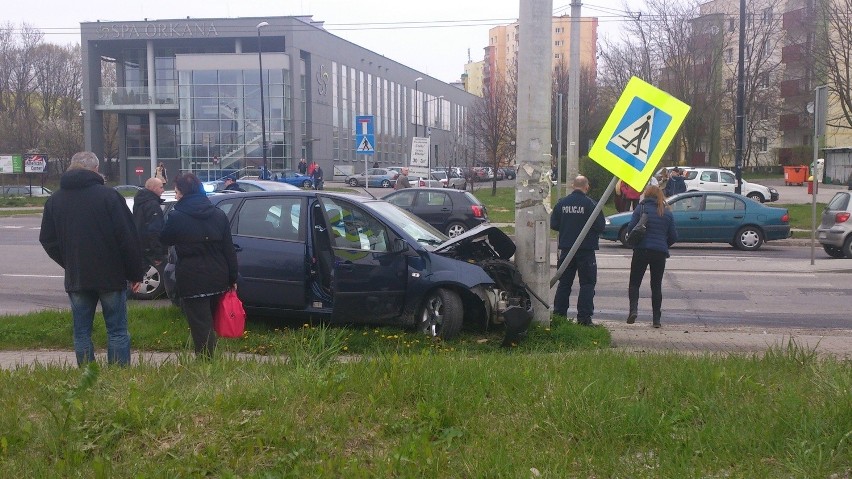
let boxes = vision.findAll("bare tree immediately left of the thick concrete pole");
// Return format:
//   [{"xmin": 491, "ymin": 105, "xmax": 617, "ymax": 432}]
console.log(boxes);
[{"xmin": 468, "ymin": 78, "xmax": 516, "ymax": 195}]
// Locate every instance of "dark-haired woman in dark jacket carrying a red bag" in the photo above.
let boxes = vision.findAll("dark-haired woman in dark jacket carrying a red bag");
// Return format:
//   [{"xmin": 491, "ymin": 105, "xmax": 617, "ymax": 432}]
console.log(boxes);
[{"xmin": 160, "ymin": 173, "xmax": 237, "ymax": 357}]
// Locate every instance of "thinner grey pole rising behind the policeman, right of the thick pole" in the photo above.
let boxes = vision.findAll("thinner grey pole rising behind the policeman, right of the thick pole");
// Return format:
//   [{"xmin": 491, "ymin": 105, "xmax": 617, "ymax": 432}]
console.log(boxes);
[{"xmin": 557, "ymin": 0, "xmax": 583, "ymax": 194}]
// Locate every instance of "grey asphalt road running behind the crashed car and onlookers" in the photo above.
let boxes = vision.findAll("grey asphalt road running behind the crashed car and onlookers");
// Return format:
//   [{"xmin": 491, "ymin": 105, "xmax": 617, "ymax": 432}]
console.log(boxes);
[{"xmin": 0, "ymin": 212, "xmax": 852, "ymax": 329}]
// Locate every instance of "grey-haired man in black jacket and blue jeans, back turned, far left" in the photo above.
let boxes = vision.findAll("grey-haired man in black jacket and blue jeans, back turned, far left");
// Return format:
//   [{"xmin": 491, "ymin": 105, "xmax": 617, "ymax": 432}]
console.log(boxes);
[{"xmin": 39, "ymin": 151, "xmax": 144, "ymax": 365}]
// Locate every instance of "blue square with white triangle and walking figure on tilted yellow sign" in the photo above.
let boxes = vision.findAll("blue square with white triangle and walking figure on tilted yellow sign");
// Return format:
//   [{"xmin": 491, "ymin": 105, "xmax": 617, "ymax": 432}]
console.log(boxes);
[{"xmin": 606, "ymin": 97, "xmax": 672, "ymax": 171}]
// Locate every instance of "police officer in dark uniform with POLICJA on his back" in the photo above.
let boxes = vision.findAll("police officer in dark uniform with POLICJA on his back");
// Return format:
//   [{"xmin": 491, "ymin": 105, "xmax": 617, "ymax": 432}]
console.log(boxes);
[{"xmin": 550, "ymin": 176, "xmax": 606, "ymax": 326}]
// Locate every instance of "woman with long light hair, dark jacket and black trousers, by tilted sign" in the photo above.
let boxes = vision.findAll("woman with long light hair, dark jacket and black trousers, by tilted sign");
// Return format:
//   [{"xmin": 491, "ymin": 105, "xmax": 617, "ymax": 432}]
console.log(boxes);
[{"xmin": 627, "ymin": 185, "xmax": 677, "ymax": 328}]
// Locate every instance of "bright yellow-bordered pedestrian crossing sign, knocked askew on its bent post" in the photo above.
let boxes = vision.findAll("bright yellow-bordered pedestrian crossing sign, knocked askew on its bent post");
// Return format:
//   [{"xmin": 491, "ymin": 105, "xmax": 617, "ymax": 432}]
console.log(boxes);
[{"xmin": 589, "ymin": 77, "xmax": 690, "ymax": 191}]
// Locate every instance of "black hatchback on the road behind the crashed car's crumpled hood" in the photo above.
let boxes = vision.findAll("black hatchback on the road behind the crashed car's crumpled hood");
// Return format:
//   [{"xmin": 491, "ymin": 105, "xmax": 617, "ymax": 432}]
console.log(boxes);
[{"xmin": 384, "ymin": 188, "xmax": 488, "ymax": 238}]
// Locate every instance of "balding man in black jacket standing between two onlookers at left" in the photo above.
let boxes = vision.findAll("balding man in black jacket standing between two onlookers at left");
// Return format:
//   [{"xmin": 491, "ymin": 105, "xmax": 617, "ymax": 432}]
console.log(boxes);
[{"xmin": 133, "ymin": 178, "xmax": 168, "ymax": 265}]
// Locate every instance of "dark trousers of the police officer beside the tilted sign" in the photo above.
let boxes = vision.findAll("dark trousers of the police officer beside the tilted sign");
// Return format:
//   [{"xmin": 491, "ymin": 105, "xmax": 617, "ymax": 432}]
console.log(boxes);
[{"xmin": 553, "ymin": 249, "xmax": 598, "ymax": 323}]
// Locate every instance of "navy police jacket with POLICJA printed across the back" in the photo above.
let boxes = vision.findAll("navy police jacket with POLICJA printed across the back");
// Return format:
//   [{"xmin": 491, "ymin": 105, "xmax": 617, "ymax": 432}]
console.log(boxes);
[{"xmin": 550, "ymin": 190, "xmax": 606, "ymax": 250}]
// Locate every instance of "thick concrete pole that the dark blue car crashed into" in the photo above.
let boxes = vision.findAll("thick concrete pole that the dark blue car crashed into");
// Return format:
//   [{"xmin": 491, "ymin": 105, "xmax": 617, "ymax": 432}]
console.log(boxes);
[{"xmin": 515, "ymin": 0, "xmax": 553, "ymax": 322}]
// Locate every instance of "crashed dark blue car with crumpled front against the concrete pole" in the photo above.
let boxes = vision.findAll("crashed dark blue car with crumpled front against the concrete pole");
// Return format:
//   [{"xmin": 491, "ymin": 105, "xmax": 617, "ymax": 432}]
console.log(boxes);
[{"xmin": 165, "ymin": 190, "xmax": 532, "ymax": 342}]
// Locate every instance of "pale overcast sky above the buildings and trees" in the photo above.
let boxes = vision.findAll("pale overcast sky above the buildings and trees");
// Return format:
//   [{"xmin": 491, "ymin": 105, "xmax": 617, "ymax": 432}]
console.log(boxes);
[{"xmin": 2, "ymin": 0, "xmax": 643, "ymax": 82}]
